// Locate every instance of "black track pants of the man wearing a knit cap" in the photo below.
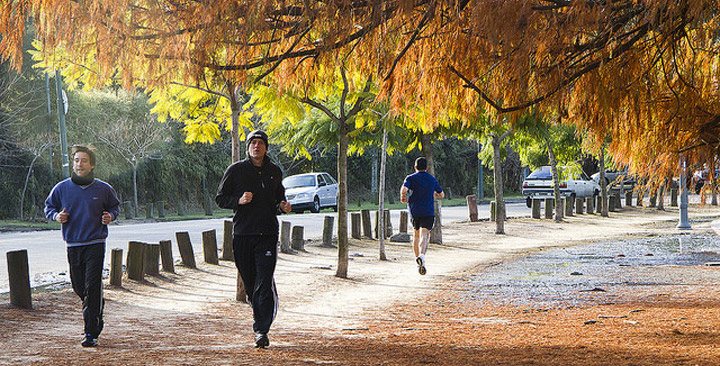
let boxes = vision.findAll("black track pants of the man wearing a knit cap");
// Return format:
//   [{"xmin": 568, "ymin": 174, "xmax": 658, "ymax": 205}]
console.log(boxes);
[{"xmin": 233, "ymin": 235, "xmax": 278, "ymax": 333}]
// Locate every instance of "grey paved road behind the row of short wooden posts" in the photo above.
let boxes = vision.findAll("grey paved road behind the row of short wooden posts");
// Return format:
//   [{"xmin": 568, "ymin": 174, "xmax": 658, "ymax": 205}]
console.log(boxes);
[{"xmin": 0, "ymin": 203, "xmax": 530, "ymax": 293}]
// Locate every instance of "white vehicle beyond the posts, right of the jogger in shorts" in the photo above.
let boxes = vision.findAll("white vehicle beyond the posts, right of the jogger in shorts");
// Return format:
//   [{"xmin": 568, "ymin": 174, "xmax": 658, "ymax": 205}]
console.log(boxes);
[{"xmin": 522, "ymin": 166, "xmax": 600, "ymax": 207}]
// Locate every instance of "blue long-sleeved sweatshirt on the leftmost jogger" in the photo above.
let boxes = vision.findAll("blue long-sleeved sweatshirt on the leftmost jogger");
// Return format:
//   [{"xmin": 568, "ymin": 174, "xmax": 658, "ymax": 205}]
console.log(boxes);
[{"xmin": 45, "ymin": 178, "xmax": 120, "ymax": 247}]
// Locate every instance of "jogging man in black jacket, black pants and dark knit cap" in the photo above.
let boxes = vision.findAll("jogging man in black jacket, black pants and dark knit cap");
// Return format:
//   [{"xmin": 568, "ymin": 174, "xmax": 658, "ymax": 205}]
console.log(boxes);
[{"xmin": 215, "ymin": 130, "xmax": 291, "ymax": 348}]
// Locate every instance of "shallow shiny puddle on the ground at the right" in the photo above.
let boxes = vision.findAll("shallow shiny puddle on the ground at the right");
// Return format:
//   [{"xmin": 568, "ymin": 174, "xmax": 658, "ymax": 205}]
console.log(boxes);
[{"xmin": 468, "ymin": 234, "xmax": 720, "ymax": 307}]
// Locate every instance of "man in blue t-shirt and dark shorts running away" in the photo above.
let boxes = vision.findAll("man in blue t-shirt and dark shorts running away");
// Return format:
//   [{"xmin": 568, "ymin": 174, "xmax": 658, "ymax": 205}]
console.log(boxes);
[{"xmin": 400, "ymin": 157, "xmax": 445, "ymax": 275}]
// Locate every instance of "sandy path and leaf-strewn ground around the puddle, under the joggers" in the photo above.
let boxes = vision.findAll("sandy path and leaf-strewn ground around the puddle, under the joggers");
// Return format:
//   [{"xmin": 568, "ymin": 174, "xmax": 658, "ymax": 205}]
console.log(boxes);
[{"xmin": 0, "ymin": 207, "xmax": 720, "ymax": 365}]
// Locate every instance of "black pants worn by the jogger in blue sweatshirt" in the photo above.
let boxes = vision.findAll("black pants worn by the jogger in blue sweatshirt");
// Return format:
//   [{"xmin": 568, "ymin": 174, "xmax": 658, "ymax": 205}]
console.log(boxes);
[{"xmin": 68, "ymin": 243, "xmax": 105, "ymax": 338}]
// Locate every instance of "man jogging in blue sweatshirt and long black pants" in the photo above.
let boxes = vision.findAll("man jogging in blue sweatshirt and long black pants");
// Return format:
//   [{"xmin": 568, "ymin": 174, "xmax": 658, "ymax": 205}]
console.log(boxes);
[{"xmin": 45, "ymin": 145, "xmax": 120, "ymax": 347}]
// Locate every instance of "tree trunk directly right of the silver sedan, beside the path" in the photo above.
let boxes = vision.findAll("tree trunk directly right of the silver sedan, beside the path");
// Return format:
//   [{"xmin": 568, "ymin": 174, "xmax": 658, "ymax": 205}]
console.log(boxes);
[{"xmin": 335, "ymin": 121, "xmax": 348, "ymax": 278}]
